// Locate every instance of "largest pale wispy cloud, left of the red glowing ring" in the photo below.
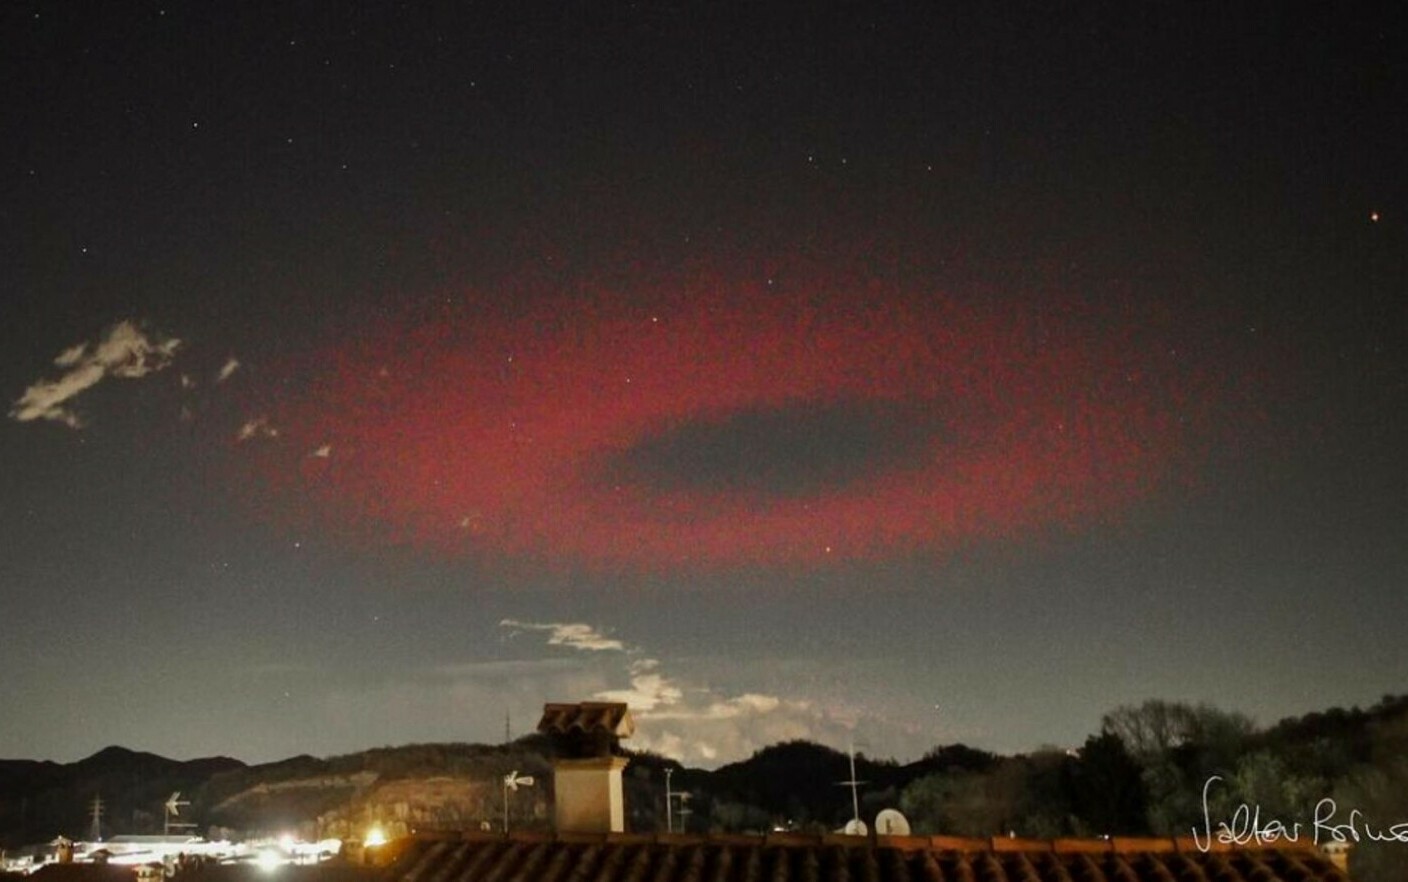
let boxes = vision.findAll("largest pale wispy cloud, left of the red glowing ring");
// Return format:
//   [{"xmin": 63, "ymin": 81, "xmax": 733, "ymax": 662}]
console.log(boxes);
[{"xmin": 10, "ymin": 321, "xmax": 182, "ymax": 428}]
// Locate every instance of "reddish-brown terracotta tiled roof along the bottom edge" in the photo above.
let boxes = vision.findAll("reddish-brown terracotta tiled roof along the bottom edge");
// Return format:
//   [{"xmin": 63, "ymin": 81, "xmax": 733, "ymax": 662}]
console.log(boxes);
[{"xmin": 368, "ymin": 834, "xmax": 1347, "ymax": 882}]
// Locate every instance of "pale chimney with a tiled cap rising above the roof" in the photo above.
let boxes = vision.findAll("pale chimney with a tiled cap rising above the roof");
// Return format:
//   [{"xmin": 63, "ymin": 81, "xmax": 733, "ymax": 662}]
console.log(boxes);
[{"xmin": 538, "ymin": 702, "xmax": 635, "ymax": 833}]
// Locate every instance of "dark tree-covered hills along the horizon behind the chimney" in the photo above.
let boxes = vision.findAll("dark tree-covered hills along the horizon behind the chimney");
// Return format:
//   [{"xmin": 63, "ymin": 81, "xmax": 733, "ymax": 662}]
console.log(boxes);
[{"xmin": 0, "ymin": 696, "xmax": 1408, "ymax": 848}]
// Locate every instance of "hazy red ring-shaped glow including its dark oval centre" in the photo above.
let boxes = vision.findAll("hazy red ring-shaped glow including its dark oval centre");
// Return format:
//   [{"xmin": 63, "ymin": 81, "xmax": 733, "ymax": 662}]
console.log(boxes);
[{"xmin": 233, "ymin": 266, "xmax": 1244, "ymax": 569}]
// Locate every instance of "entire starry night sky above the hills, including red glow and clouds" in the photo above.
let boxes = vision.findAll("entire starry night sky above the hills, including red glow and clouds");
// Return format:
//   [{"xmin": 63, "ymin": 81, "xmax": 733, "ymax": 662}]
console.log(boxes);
[{"xmin": 0, "ymin": 1, "xmax": 1408, "ymax": 765}]
